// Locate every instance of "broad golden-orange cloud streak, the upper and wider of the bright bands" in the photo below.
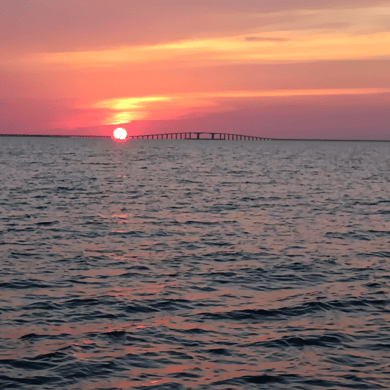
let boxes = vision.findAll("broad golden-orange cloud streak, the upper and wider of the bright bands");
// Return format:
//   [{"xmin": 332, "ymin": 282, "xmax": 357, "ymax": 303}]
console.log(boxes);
[{"xmin": 19, "ymin": 31, "xmax": 390, "ymax": 70}]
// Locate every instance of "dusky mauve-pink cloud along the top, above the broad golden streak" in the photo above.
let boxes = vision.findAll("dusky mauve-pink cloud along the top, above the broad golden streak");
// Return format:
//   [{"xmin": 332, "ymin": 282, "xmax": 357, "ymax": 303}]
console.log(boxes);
[{"xmin": 0, "ymin": 0, "xmax": 389, "ymax": 56}]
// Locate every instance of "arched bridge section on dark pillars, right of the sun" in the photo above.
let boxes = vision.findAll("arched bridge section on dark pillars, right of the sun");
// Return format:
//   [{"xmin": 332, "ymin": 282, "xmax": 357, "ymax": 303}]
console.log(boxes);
[{"xmin": 127, "ymin": 131, "xmax": 272, "ymax": 141}]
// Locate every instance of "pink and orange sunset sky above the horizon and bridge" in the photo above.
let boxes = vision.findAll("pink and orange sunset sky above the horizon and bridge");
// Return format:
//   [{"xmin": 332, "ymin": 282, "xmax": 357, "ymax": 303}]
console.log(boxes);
[{"xmin": 0, "ymin": 0, "xmax": 390, "ymax": 140}]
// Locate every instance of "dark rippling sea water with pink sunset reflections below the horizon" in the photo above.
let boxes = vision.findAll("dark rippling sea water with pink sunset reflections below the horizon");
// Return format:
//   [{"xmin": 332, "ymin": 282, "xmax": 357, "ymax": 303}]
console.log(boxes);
[{"xmin": 0, "ymin": 137, "xmax": 390, "ymax": 389}]
